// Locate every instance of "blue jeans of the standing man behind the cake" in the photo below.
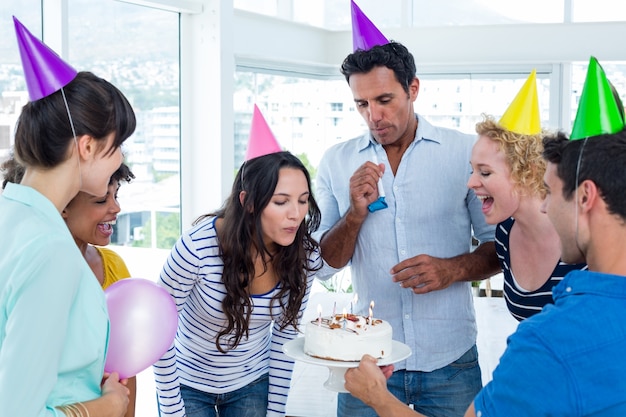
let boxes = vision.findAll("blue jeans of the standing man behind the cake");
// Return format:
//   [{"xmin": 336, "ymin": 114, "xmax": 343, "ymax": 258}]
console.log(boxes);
[{"xmin": 337, "ymin": 345, "xmax": 482, "ymax": 417}]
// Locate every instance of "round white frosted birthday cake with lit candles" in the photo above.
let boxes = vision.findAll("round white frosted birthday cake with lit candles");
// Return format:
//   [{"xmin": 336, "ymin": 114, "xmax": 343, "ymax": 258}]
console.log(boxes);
[{"xmin": 304, "ymin": 314, "xmax": 392, "ymax": 361}]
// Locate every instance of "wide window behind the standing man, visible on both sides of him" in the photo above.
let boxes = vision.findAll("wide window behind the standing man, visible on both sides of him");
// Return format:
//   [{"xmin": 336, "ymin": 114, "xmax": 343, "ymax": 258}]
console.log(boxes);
[{"xmin": 234, "ymin": 72, "xmax": 550, "ymax": 176}]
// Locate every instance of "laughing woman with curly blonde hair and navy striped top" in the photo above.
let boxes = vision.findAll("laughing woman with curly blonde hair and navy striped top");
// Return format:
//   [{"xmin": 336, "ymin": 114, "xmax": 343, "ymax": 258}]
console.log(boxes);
[{"xmin": 467, "ymin": 116, "xmax": 586, "ymax": 321}]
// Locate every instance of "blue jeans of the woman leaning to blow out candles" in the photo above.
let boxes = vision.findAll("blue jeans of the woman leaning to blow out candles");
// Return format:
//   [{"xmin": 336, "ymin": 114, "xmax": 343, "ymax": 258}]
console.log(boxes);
[{"xmin": 180, "ymin": 374, "xmax": 269, "ymax": 417}]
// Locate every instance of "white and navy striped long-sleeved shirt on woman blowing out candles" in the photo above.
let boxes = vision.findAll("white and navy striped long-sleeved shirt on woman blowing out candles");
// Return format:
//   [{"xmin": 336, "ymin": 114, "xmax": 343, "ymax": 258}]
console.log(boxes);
[{"xmin": 154, "ymin": 217, "xmax": 322, "ymax": 416}]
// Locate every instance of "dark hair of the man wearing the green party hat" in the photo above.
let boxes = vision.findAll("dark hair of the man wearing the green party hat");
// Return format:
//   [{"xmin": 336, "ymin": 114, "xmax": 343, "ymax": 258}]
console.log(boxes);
[{"xmin": 543, "ymin": 130, "xmax": 626, "ymax": 220}]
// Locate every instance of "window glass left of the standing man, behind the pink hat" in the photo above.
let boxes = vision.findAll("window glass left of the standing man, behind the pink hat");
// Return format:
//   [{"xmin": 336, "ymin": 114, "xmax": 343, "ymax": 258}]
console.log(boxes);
[{"xmin": 234, "ymin": 72, "xmax": 365, "ymax": 167}]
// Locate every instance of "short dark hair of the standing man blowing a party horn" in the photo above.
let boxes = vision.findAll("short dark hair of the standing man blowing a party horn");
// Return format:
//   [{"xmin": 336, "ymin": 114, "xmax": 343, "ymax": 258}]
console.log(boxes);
[{"xmin": 341, "ymin": 41, "xmax": 416, "ymax": 94}]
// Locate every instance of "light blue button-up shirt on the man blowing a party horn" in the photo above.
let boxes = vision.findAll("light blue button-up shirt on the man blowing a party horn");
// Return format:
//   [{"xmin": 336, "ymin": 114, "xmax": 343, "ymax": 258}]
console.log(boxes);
[{"xmin": 315, "ymin": 115, "xmax": 495, "ymax": 371}]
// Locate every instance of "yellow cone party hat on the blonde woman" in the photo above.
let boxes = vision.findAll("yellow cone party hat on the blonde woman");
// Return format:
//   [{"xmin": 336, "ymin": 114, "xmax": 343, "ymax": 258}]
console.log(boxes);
[{"xmin": 498, "ymin": 70, "xmax": 541, "ymax": 135}]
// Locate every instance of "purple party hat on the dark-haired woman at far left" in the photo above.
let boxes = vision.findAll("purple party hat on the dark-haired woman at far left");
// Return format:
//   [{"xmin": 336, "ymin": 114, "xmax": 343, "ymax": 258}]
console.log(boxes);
[{"xmin": 13, "ymin": 16, "xmax": 77, "ymax": 101}]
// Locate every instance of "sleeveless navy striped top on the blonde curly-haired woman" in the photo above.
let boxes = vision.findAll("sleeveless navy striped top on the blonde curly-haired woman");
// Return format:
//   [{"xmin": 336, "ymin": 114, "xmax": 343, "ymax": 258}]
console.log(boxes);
[{"xmin": 496, "ymin": 217, "xmax": 587, "ymax": 321}]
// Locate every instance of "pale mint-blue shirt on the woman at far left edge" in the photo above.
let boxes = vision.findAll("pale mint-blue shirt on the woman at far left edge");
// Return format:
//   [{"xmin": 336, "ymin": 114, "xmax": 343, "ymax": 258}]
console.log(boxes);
[{"xmin": 0, "ymin": 183, "xmax": 109, "ymax": 417}]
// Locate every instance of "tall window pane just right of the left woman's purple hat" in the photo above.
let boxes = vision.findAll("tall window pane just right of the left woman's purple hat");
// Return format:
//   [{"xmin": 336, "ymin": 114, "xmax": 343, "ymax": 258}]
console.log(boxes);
[{"xmin": 68, "ymin": 0, "xmax": 180, "ymax": 280}]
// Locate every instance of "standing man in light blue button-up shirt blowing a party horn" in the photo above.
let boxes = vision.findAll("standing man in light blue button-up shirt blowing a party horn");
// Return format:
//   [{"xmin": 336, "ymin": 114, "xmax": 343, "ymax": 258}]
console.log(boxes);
[{"xmin": 316, "ymin": 42, "xmax": 500, "ymax": 417}]
